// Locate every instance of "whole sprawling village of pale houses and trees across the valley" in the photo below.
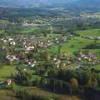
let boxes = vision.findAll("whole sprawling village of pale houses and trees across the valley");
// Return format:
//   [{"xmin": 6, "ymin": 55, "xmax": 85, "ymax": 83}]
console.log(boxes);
[{"xmin": 0, "ymin": 31, "xmax": 100, "ymax": 90}]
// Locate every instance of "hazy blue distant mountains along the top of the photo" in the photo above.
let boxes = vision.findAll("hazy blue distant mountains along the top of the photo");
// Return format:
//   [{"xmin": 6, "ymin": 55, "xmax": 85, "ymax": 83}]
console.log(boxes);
[{"xmin": 0, "ymin": 0, "xmax": 100, "ymax": 11}]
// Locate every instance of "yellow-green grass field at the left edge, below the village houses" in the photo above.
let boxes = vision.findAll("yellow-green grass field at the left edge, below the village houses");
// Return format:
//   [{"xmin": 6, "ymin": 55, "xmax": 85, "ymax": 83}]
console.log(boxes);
[{"xmin": 0, "ymin": 65, "xmax": 15, "ymax": 80}]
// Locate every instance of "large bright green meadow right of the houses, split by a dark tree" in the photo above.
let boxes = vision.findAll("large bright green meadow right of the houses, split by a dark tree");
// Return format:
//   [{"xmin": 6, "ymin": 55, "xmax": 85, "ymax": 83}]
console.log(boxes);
[{"xmin": 50, "ymin": 37, "xmax": 94, "ymax": 55}]
